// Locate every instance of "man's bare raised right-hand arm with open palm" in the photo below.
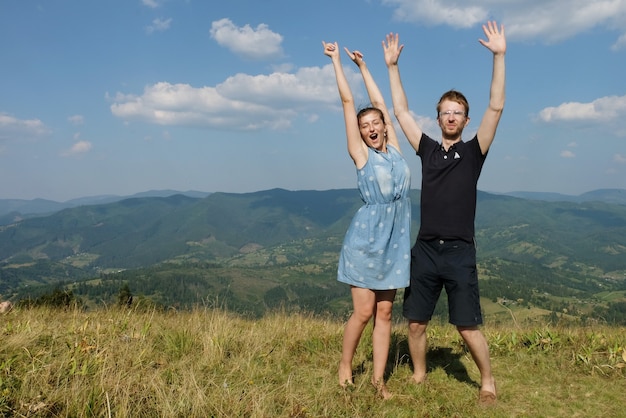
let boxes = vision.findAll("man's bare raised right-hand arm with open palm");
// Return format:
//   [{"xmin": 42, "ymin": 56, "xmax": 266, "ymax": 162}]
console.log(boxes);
[{"xmin": 477, "ymin": 22, "xmax": 506, "ymax": 154}]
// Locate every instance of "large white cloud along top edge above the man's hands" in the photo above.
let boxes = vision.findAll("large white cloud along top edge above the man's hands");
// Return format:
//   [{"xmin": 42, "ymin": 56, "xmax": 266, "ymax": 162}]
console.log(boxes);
[{"xmin": 383, "ymin": 0, "xmax": 626, "ymax": 46}]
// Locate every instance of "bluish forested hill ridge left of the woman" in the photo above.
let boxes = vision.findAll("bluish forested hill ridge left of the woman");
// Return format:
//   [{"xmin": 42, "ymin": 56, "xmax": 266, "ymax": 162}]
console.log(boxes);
[{"xmin": 0, "ymin": 189, "xmax": 359, "ymax": 268}]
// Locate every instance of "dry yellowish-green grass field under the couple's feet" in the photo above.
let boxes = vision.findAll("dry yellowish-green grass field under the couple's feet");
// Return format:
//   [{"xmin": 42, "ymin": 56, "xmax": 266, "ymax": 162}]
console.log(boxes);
[{"xmin": 0, "ymin": 308, "xmax": 626, "ymax": 417}]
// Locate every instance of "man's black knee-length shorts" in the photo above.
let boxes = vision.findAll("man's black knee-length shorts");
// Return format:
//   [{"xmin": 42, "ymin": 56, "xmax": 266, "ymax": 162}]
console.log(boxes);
[{"xmin": 402, "ymin": 239, "xmax": 483, "ymax": 327}]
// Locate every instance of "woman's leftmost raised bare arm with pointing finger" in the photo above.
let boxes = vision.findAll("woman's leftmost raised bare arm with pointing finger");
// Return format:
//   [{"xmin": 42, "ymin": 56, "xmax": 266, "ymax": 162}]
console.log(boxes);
[{"xmin": 322, "ymin": 41, "xmax": 367, "ymax": 168}]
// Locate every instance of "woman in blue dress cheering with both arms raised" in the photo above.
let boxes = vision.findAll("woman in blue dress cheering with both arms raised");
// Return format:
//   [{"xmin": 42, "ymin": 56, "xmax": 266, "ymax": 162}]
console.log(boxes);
[{"xmin": 322, "ymin": 42, "xmax": 411, "ymax": 399}]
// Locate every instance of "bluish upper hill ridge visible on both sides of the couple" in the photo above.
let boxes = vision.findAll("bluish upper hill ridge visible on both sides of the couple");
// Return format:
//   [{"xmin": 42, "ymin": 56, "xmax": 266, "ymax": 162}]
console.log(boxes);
[{"xmin": 0, "ymin": 189, "xmax": 626, "ymax": 269}]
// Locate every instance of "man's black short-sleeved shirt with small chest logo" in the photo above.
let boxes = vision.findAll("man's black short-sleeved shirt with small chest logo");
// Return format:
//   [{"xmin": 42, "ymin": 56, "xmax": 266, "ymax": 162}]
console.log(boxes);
[{"xmin": 417, "ymin": 134, "xmax": 487, "ymax": 242}]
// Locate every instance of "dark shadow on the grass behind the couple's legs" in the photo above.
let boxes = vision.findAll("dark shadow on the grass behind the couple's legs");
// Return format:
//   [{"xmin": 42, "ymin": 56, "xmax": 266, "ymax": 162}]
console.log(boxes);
[{"xmin": 385, "ymin": 333, "xmax": 480, "ymax": 387}]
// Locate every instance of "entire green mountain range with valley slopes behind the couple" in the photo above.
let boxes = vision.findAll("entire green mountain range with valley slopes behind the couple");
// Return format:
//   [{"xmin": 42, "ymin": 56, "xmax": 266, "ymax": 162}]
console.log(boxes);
[{"xmin": 0, "ymin": 189, "xmax": 626, "ymax": 319}]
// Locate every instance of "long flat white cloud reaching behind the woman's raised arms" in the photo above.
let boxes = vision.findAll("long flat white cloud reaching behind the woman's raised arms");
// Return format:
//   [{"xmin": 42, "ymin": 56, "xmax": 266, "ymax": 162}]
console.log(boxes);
[{"xmin": 107, "ymin": 64, "xmax": 362, "ymax": 130}]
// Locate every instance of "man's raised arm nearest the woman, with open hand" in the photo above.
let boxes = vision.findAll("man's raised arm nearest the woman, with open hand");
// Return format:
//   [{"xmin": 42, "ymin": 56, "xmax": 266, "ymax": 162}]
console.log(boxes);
[{"xmin": 383, "ymin": 34, "xmax": 422, "ymax": 151}]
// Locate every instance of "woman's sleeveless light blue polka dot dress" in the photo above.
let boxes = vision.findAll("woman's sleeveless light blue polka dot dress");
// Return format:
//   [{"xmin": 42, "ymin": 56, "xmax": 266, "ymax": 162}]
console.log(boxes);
[{"xmin": 337, "ymin": 145, "xmax": 411, "ymax": 290}]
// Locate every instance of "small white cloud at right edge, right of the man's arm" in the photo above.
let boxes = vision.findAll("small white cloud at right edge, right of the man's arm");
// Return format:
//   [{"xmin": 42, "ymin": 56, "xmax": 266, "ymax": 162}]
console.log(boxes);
[{"xmin": 539, "ymin": 96, "xmax": 626, "ymax": 122}]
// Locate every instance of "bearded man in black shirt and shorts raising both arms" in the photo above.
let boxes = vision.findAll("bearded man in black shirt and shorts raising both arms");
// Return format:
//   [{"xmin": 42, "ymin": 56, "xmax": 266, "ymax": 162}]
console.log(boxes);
[{"xmin": 383, "ymin": 22, "xmax": 506, "ymax": 404}]
